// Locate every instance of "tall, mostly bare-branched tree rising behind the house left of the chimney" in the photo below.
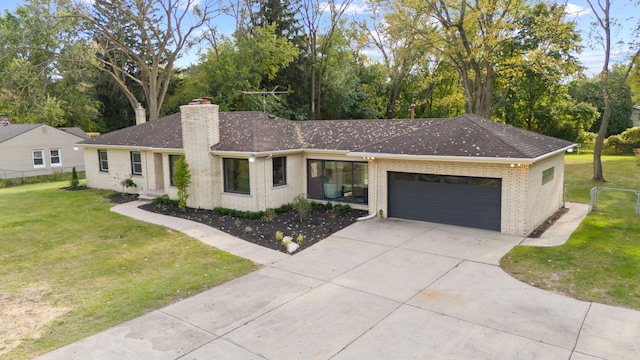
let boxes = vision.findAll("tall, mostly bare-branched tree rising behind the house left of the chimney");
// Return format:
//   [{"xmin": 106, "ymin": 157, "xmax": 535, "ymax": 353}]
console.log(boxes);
[{"xmin": 77, "ymin": 0, "xmax": 219, "ymax": 120}]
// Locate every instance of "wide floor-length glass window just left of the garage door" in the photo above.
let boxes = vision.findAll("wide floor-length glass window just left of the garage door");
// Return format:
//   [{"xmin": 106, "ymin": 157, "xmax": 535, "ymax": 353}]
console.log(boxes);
[{"xmin": 307, "ymin": 160, "xmax": 369, "ymax": 204}]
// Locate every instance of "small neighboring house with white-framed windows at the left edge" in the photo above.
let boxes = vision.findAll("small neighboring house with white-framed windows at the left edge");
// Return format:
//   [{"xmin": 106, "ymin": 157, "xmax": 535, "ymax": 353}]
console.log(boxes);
[{"xmin": 0, "ymin": 120, "xmax": 89, "ymax": 179}]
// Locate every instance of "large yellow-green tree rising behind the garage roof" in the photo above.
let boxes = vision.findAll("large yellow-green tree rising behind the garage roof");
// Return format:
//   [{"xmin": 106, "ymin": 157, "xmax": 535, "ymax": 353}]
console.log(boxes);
[{"xmin": 423, "ymin": 0, "xmax": 579, "ymax": 117}]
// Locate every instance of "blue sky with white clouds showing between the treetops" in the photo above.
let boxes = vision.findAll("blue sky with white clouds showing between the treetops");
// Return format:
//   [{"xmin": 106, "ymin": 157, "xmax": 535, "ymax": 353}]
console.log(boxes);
[{"xmin": 0, "ymin": 0, "xmax": 640, "ymax": 75}]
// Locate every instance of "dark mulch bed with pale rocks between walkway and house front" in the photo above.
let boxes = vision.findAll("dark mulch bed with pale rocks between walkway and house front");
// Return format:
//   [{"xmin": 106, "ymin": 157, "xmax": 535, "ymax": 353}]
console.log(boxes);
[{"xmin": 140, "ymin": 203, "xmax": 367, "ymax": 253}]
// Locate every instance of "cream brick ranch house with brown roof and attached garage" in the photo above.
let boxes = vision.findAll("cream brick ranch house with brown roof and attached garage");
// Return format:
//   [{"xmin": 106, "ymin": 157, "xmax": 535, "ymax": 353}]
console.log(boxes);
[{"xmin": 79, "ymin": 105, "xmax": 575, "ymax": 235}]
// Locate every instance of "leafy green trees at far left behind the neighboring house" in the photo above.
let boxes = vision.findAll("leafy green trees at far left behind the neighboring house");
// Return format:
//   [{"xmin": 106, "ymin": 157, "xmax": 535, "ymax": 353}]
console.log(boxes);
[{"xmin": 0, "ymin": 0, "xmax": 99, "ymax": 131}]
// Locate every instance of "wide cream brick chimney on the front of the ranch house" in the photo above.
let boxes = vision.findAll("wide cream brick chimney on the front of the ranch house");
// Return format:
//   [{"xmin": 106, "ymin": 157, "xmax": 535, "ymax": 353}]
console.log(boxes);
[{"xmin": 180, "ymin": 102, "xmax": 220, "ymax": 209}]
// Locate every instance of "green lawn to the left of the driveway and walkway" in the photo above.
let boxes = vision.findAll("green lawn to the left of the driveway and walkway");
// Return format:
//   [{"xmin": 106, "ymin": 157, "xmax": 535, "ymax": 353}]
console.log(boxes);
[{"xmin": 0, "ymin": 183, "xmax": 257, "ymax": 359}]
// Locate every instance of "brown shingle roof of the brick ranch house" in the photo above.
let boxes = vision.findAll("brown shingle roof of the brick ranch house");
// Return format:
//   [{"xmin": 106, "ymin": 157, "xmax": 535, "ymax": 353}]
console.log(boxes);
[{"xmin": 82, "ymin": 112, "xmax": 572, "ymax": 159}]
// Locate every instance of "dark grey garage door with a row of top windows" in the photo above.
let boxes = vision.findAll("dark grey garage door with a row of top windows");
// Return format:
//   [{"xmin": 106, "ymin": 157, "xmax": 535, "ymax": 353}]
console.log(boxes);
[{"xmin": 389, "ymin": 172, "xmax": 502, "ymax": 231}]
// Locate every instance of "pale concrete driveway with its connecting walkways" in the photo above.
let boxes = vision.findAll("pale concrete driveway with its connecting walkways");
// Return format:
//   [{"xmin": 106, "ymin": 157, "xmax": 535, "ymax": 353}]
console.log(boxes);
[{"xmin": 42, "ymin": 203, "xmax": 640, "ymax": 360}]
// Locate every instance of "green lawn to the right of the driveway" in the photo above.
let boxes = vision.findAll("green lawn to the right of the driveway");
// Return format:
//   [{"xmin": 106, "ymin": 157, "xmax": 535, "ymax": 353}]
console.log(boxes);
[{"xmin": 500, "ymin": 155, "xmax": 640, "ymax": 310}]
